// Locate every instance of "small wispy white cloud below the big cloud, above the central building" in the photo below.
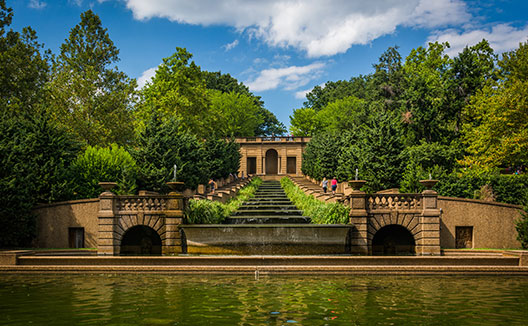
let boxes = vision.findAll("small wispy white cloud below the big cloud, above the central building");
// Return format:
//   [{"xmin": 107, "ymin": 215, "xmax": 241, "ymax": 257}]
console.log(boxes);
[{"xmin": 245, "ymin": 62, "xmax": 325, "ymax": 92}]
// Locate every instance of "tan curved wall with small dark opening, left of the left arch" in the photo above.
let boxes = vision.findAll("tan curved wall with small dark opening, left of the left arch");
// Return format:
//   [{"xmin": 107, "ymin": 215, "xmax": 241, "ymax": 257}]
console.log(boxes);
[{"xmin": 34, "ymin": 198, "xmax": 99, "ymax": 248}]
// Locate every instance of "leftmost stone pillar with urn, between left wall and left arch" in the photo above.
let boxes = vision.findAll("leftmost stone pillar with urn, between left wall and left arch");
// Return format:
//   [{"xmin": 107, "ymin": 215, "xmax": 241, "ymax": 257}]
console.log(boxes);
[{"xmin": 97, "ymin": 183, "xmax": 119, "ymax": 256}]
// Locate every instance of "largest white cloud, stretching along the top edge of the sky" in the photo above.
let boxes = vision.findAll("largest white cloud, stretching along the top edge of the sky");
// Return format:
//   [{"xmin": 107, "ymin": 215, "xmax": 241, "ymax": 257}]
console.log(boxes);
[{"xmin": 125, "ymin": 0, "xmax": 471, "ymax": 57}]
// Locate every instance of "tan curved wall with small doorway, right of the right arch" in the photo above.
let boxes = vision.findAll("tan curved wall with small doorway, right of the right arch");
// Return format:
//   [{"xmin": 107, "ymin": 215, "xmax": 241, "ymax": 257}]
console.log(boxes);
[{"xmin": 438, "ymin": 197, "xmax": 521, "ymax": 249}]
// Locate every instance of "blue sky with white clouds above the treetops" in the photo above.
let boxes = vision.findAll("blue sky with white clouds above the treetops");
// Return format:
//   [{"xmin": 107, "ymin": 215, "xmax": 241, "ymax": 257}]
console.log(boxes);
[{"xmin": 7, "ymin": 0, "xmax": 528, "ymax": 130}]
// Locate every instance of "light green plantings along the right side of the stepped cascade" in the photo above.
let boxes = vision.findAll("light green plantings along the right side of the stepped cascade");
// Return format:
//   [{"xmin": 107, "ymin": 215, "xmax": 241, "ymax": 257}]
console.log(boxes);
[{"xmin": 281, "ymin": 177, "xmax": 349, "ymax": 224}]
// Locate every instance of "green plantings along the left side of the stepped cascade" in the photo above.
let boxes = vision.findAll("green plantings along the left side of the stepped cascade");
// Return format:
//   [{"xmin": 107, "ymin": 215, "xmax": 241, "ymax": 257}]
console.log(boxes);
[{"xmin": 185, "ymin": 178, "xmax": 262, "ymax": 224}]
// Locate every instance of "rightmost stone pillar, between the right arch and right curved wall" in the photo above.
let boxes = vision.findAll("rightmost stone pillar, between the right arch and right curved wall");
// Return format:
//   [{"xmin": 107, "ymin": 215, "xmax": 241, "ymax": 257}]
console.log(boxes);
[{"xmin": 416, "ymin": 189, "xmax": 441, "ymax": 255}]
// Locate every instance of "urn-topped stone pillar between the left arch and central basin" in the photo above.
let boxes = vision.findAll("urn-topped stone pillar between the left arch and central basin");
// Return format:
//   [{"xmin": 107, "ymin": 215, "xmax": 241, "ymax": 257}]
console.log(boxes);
[{"xmin": 166, "ymin": 182, "xmax": 185, "ymax": 255}]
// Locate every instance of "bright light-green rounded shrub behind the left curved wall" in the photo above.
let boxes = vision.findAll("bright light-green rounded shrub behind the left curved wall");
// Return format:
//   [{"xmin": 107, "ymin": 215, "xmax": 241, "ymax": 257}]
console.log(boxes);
[{"xmin": 72, "ymin": 144, "xmax": 137, "ymax": 198}]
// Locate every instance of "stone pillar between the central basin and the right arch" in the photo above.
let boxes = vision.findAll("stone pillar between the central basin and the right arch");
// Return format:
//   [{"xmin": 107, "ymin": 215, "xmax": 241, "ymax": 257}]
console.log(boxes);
[{"xmin": 346, "ymin": 190, "xmax": 371, "ymax": 255}]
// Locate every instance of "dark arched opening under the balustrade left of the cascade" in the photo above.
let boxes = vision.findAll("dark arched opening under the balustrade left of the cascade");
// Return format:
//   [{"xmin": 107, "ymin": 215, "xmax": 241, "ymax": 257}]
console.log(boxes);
[{"xmin": 120, "ymin": 225, "xmax": 161, "ymax": 255}]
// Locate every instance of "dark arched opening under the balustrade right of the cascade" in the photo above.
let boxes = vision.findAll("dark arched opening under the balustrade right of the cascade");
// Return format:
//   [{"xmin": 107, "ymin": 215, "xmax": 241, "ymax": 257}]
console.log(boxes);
[{"xmin": 372, "ymin": 224, "xmax": 416, "ymax": 255}]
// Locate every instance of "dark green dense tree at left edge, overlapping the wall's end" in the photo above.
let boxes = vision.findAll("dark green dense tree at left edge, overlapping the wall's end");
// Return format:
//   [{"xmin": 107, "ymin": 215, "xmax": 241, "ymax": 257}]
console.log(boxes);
[{"xmin": 0, "ymin": 113, "xmax": 79, "ymax": 247}]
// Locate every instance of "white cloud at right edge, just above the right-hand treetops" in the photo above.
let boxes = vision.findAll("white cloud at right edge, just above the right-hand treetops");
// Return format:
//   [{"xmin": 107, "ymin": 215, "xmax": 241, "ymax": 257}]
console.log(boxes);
[{"xmin": 428, "ymin": 24, "xmax": 528, "ymax": 57}]
